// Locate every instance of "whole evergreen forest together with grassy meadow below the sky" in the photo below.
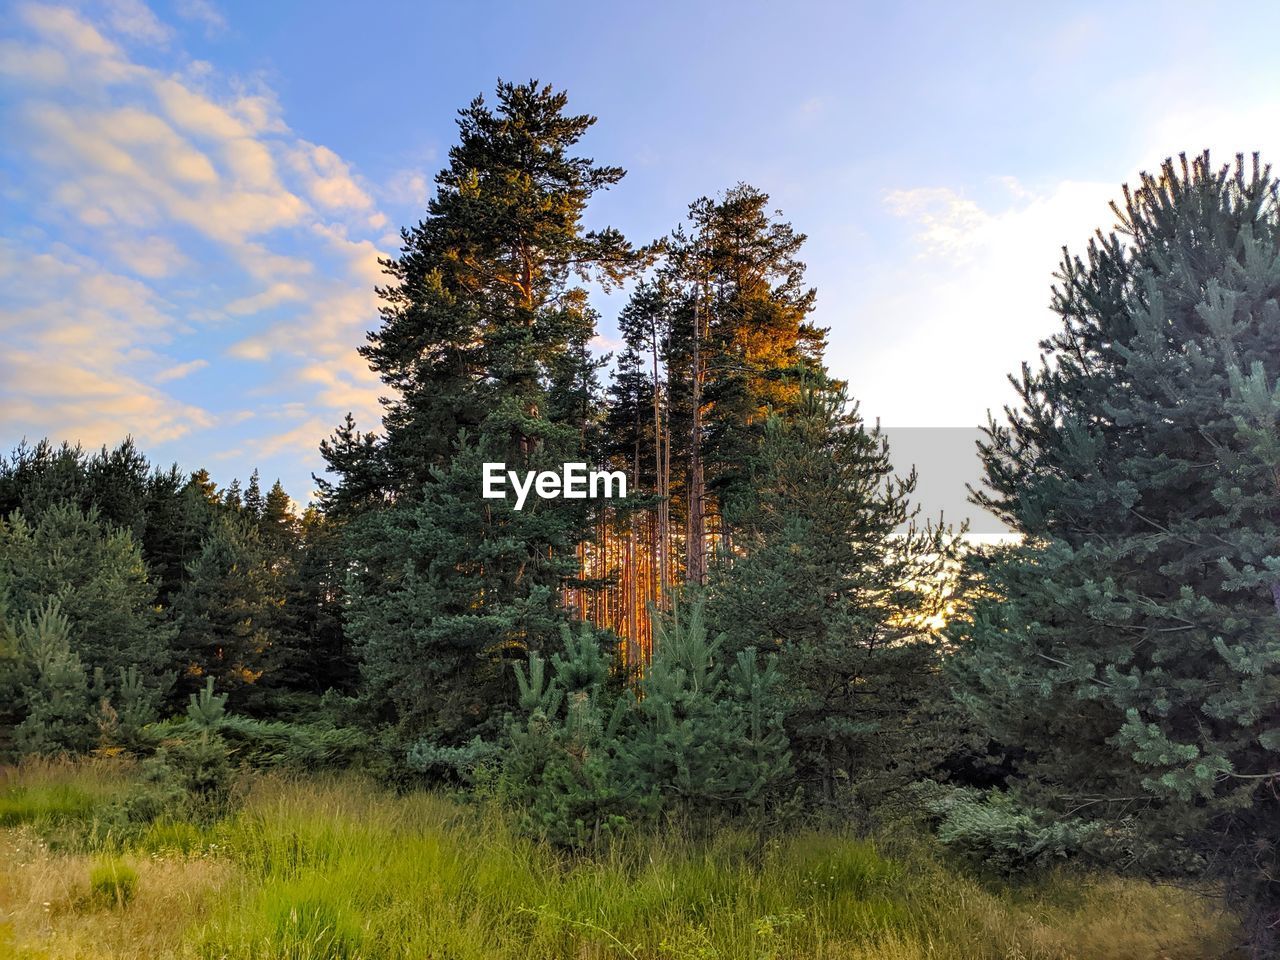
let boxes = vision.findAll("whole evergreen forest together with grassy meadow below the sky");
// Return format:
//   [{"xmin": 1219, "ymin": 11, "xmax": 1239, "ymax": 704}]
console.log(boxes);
[{"xmin": 0, "ymin": 82, "xmax": 1280, "ymax": 960}]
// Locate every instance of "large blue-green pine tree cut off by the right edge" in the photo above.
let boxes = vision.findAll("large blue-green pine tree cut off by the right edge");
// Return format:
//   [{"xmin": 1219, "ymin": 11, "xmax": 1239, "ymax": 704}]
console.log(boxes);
[{"xmin": 956, "ymin": 154, "xmax": 1280, "ymax": 956}]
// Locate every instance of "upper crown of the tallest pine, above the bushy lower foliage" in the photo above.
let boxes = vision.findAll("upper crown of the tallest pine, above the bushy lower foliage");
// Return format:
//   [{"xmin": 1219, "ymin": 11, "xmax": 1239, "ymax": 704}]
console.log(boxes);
[{"xmin": 340, "ymin": 81, "xmax": 639, "ymax": 494}]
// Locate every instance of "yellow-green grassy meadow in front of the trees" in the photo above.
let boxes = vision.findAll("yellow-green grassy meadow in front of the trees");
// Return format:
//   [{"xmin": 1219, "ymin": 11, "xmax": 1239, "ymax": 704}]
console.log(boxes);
[{"xmin": 0, "ymin": 772, "xmax": 1235, "ymax": 960}]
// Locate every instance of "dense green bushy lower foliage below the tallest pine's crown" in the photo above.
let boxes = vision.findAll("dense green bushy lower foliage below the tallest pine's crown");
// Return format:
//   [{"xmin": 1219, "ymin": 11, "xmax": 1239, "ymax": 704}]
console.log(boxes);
[{"xmin": 347, "ymin": 420, "xmax": 576, "ymax": 746}]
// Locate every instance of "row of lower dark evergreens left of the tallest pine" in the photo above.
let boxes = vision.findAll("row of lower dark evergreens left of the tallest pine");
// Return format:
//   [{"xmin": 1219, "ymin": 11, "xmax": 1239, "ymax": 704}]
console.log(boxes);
[{"xmin": 0, "ymin": 439, "xmax": 353, "ymax": 754}]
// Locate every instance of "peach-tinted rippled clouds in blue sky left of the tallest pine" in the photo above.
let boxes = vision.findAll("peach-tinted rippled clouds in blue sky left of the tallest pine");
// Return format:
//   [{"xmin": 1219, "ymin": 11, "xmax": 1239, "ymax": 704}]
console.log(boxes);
[{"xmin": 0, "ymin": 0, "xmax": 387, "ymax": 471}]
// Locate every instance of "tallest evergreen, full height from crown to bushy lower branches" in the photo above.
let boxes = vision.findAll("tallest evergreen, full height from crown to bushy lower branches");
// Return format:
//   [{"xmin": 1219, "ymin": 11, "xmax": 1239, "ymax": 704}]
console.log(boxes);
[{"xmin": 324, "ymin": 82, "xmax": 639, "ymax": 745}]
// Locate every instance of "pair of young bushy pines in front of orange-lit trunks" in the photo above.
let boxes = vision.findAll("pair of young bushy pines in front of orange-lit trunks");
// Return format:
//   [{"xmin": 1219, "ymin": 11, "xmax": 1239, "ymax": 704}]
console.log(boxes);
[{"xmin": 499, "ymin": 604, "xmax": 791, "ymax": 847}]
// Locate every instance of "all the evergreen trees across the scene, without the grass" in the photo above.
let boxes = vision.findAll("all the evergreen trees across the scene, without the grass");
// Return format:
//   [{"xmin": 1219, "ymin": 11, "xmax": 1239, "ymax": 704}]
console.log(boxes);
[{"xmin": 0, "ymin": 83, "xmax": 1280, "ymax": 956}]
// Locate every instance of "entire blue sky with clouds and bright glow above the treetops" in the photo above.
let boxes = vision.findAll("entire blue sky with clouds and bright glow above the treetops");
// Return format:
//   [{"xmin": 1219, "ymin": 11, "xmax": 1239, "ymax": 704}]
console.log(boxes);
[{"xmin": 0, "ymin": 0, "xmax": 1280, "ymax": 519}]
